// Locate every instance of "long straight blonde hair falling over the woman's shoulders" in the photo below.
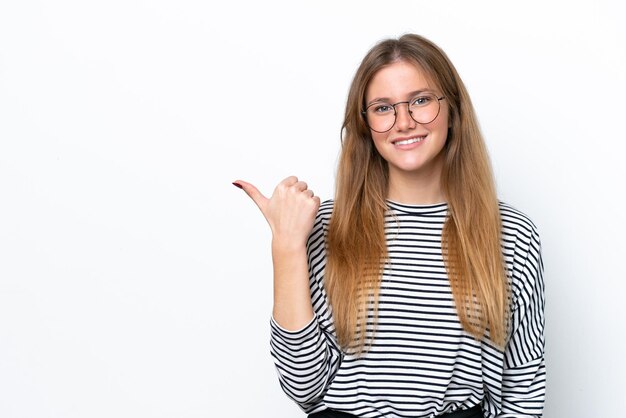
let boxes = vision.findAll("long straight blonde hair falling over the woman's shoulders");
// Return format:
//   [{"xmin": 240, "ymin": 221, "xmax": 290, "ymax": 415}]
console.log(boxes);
[{"xmin": 324, "ymin": 34, "xmax": 509, "ymax": 353}]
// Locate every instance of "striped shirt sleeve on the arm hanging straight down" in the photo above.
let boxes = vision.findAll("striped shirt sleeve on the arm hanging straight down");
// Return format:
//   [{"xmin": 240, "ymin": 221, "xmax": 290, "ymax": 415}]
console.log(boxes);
[{"xmin": 498, "ymin": 228, "xmax": 546, "ymax": 418}]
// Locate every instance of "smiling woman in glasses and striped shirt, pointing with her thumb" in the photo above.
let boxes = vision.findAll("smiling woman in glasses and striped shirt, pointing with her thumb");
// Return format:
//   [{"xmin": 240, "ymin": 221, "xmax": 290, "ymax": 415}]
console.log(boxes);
[{"xmin": 235, "ymin": 35, "xmax": 545, "ymax": 418}]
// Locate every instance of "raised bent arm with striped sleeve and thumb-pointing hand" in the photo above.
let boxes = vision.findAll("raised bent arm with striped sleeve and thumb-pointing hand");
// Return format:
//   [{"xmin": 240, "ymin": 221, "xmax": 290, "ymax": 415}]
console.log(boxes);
[{"xmin": 236, "ymin": 177, "xmax": 341, "ymax": 412}]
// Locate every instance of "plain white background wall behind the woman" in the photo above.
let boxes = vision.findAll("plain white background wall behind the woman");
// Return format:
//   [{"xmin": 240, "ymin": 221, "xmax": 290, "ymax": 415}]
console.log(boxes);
[{"xmin": 0, "ymin": 0, "xmax": 626, "ymax": 418}]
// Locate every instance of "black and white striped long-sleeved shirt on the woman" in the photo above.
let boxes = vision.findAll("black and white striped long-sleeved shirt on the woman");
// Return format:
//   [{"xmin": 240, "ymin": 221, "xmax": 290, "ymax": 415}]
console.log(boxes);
[{"xmin": 270, "ymin": 201, "xmax": 545, "ymax": 418}]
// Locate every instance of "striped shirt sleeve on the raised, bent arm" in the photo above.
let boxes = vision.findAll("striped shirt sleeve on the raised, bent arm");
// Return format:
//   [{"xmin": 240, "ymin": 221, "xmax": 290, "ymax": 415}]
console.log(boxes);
[{"xmin": 270, "ymin": 203, "xmax": 342, "ymax": 413}]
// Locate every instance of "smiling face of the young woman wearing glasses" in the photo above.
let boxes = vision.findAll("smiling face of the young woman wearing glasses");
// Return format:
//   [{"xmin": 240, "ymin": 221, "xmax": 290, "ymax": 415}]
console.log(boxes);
[{"xmin": 365, "ymin": 61, "xmax": 448, "ymax": 177}]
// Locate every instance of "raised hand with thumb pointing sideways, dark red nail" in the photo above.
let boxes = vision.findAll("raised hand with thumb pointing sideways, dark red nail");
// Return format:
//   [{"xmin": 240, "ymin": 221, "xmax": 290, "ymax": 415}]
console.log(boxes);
[{"xmin": 234, "ymin": 176, "xmax": 320, "ymax": 246}]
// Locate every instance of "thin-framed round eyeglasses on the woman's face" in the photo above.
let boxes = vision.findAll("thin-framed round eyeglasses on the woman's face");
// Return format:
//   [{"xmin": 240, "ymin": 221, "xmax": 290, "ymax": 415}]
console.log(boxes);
[{"xmin": 361, "ymin": 93, "xmax": 445, "ymax": 133}]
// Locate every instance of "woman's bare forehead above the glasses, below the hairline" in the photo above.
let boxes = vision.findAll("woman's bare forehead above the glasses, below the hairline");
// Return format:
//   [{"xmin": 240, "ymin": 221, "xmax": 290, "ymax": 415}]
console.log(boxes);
[{"xmin": 365, "ymin": 61, "xmax": 436, "ymax": 102}]
